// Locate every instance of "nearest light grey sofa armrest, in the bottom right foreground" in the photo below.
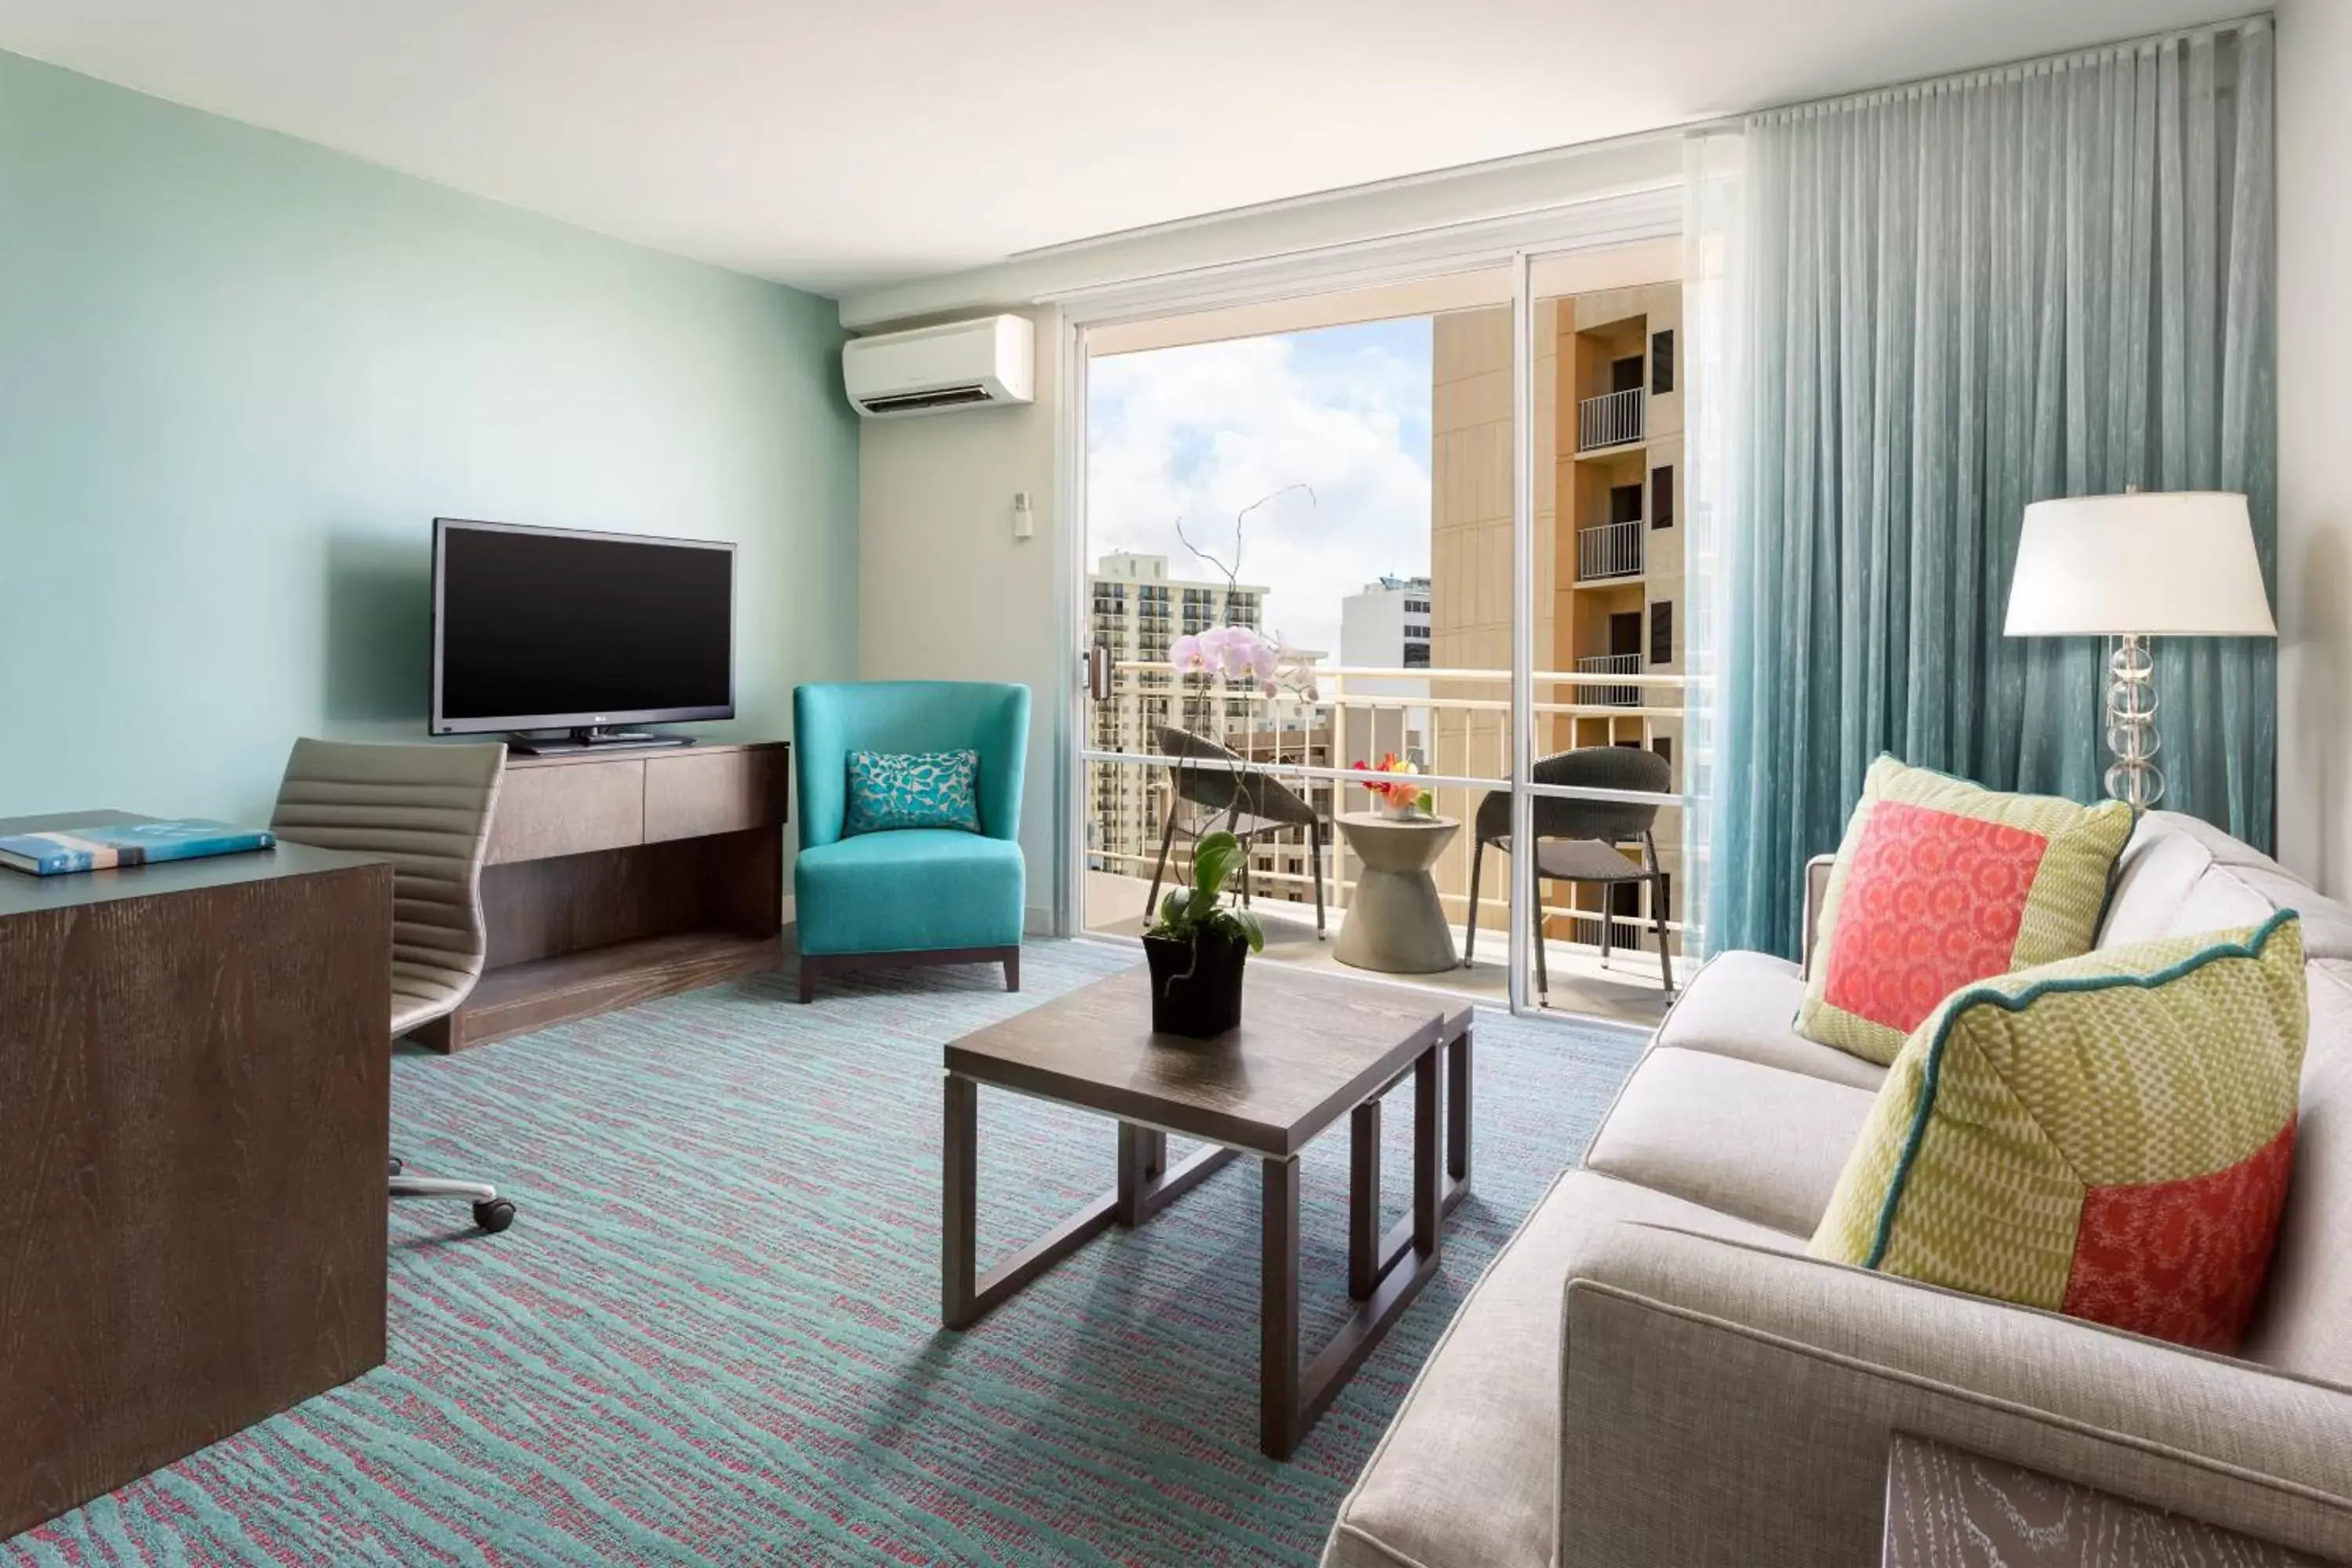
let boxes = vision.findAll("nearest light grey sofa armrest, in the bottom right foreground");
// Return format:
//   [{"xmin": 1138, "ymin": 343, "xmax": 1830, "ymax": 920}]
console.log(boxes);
[{"xmin": 1557, "ymin": 1225, "xmax": 2352, "ymax": 1568}]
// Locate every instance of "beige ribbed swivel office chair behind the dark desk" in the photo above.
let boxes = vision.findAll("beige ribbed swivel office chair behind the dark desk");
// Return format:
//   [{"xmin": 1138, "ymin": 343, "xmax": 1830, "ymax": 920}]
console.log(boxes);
[{"xmin": 270, "ymin": 741, "xmax": 515, "ymax": 1232}]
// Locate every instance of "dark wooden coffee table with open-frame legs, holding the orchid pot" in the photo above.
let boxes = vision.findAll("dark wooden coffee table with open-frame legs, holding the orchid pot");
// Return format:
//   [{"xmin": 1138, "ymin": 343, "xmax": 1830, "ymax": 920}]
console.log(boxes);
[{"xmin": 941, "ymin": 964, "xmax": 1470, "ymax": 1460}]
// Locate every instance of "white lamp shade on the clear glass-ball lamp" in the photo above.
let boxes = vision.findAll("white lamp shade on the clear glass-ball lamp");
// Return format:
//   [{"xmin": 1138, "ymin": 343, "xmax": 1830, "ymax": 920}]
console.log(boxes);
[{"xmin": 2002, "ymin": 492, "xmax": 2279, "ymax": 637}]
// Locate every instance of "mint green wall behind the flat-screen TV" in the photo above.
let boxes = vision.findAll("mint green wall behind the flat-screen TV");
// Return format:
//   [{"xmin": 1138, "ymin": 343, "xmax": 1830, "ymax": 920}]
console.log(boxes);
[{"xmin": 0, "ymin": 54, "xmax": 858, "ymax": 818}]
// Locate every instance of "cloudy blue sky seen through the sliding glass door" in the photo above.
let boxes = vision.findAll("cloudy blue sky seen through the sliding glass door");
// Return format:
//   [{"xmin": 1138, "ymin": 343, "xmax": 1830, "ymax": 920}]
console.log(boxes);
[{"xmin": 1087, "ymin": 318, "xmax": 1430, "ymax": 659}]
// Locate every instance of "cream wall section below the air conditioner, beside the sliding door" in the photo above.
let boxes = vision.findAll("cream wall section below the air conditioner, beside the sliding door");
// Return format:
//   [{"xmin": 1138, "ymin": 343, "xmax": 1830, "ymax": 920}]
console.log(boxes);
[{"xmin": 858, "ymin": 310, "xmax": 1077, "ymax": 931}]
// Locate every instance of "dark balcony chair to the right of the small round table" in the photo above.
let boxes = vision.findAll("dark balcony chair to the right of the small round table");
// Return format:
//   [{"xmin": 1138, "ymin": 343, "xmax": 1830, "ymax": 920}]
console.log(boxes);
[{"xmin": 1463, "ymin": 746, "xmax": 1675, "ymax": 999}]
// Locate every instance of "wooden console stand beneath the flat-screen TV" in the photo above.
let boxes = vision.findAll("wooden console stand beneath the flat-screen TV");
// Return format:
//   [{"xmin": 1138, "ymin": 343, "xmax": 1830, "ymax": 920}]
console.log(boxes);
[{"xmin": 412, "ymin": 741, "xmax": 793, "ymax": 1051}]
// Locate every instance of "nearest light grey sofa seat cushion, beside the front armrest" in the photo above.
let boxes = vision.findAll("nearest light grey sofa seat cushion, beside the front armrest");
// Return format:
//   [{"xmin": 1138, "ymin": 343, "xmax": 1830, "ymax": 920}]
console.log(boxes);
[{"xmin": 1324, "ymin": 1171, "xmax": 1802, "ymax": 1568}]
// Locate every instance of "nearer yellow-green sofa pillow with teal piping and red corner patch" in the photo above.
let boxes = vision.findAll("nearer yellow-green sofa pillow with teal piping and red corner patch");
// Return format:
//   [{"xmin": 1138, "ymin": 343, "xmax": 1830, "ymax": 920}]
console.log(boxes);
[{"xmin": 1811, "ymin": 909, "xmax": 2307, "ymax": 1349}]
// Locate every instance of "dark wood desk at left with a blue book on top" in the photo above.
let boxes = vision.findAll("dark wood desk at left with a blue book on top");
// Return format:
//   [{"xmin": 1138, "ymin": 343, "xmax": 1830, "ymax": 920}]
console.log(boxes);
[{"xmin": 0, "ymin": 811, "xmax": 393, "ymax": 1537}]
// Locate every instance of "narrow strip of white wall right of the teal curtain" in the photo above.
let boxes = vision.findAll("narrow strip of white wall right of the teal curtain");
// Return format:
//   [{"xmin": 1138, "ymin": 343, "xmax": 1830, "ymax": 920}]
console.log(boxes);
[{"xmin": 2279, "ymin": 0, "xmax": 2352, "ymax": 895}]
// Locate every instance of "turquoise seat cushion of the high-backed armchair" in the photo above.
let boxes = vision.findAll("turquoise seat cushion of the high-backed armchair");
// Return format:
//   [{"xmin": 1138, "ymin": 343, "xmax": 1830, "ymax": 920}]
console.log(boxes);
[{"xmin": 793, "ymin": 827, "xmax": 1023, "ymax": 952}]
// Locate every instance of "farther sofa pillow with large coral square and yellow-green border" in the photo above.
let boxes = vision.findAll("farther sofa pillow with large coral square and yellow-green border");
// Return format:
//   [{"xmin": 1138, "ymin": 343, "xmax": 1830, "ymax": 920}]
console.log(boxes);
[{"xmin": 1797, "ymin": 757, "xmax": 2131, "ymax": 1065}]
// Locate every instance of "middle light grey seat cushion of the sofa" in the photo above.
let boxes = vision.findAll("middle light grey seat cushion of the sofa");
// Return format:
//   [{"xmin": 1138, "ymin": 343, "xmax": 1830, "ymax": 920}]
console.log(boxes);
[{"xmin": 1585, "ymin": 1048, "xmax": 1875, "ymax": 1236}]
